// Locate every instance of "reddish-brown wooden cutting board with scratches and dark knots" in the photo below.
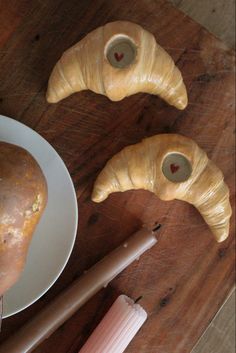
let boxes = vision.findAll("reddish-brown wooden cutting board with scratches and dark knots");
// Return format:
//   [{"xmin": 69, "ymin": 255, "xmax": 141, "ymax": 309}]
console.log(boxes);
[{"xmin": 0, "ymin": 0, "xmax": 235, "ymax": 353}]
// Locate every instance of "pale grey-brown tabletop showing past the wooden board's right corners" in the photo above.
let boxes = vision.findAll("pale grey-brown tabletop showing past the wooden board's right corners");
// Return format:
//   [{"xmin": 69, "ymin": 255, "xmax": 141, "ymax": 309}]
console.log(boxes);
[{"xmin": 170, "ymin": 0, "xmax": 236, "ymax": 353}]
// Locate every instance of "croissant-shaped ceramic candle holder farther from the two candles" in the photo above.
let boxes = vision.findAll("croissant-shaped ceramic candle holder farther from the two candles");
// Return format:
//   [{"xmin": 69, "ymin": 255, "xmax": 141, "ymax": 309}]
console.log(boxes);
[{"xmin": 46, "ymin": 21, "xmax": 188, "ymax": 109}]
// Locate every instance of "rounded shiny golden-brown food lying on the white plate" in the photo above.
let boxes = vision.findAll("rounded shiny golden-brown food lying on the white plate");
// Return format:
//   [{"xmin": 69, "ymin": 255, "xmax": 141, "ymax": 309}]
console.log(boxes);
[{"xmin": 0, "ymin": 142, "xmax": 47, "ymax": 297}]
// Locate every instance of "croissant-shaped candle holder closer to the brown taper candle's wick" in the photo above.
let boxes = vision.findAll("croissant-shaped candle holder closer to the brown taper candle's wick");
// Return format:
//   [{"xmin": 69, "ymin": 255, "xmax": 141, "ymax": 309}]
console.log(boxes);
[{"xmin": 92, "ymin": 134, "xmax": 232, "ymax": 242}]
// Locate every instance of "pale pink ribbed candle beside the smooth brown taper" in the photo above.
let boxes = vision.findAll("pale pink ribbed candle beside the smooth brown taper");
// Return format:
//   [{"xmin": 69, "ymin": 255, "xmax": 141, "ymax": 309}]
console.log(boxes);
[{"xmin": 79, "ymin": 295, "xmax": 147, "ymax": 353}]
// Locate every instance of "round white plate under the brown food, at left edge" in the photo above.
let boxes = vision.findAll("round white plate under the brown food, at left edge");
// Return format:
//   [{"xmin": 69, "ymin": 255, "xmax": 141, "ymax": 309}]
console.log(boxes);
[{"xmin": 0, "ymin": 115, "xmax": 78, "ymax": 318}]
